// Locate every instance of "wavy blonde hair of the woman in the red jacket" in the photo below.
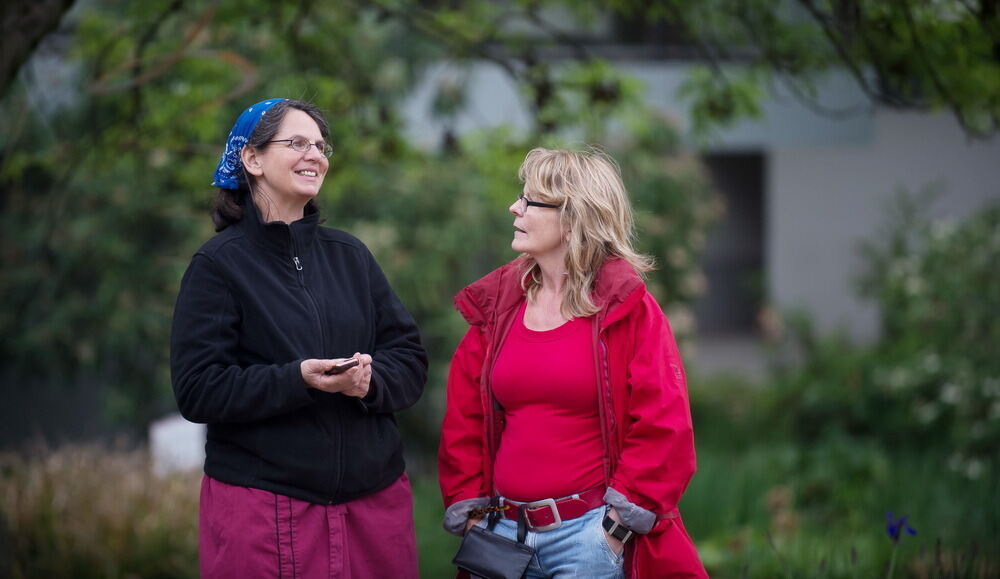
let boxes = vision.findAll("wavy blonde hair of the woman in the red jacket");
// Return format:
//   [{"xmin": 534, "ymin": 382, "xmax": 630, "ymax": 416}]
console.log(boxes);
[{"xmin": 518, "ymin": 147, "xmax": 653, "ymax": 318}]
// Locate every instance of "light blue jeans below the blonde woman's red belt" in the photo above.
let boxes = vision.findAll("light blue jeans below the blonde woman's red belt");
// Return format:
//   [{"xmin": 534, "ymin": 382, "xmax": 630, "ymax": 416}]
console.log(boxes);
[{"xmin": 478, "ymin": 506, "xmax": 625, "ymax": 579}]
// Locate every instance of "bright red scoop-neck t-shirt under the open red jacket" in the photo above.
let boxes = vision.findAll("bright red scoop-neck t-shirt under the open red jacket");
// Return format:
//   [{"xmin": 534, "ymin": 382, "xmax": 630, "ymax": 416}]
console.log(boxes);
[{"xmin": 492, "ymin": 304, "xmax": 604, "ymax": 501}]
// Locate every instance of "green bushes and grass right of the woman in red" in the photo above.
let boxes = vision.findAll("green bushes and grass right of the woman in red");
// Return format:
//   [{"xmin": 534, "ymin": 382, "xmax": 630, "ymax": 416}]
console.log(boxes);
[{"xmin": 681, "ymin": 195, "xmax": 1000, "ymax": 577}]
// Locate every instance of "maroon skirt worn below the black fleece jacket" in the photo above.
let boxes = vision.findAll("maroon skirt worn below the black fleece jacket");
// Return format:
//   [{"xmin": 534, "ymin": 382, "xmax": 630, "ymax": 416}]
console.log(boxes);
[{"xmin": 198, "ymin": 473, "xmax": 419, "ymax": 579}]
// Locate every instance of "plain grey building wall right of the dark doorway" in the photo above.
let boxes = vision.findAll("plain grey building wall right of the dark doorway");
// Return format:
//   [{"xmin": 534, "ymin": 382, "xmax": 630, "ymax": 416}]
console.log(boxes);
[{"xmin": 765, "ymin": 110, "xmax": 1000, "ymax": 340}]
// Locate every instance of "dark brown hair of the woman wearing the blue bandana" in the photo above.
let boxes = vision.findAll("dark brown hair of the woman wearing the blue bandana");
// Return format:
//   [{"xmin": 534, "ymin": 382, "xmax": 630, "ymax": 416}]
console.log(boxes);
[{"xmin": 212, "ymin": 99, "xmax": 330, "ymax": 231}]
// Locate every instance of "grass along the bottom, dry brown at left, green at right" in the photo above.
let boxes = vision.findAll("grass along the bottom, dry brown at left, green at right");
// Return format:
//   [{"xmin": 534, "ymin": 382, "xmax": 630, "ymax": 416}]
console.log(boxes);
[{"xmin": 0, "ymin": 436, "xmax": 1000, "ymax": 579}]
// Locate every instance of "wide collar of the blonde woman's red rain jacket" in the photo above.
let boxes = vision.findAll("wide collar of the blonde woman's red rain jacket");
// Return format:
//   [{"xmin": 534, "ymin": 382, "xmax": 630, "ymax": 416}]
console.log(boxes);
[{"xmin": 454, "ymin": 257, "xmax": 646, "ymax": 329}]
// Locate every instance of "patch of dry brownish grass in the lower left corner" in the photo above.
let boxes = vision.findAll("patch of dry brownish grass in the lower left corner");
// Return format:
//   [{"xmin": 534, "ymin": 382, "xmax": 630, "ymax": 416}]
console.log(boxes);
[{"xmin": 0, "ymin": 446, "xmax": 200, "ymax": 579}]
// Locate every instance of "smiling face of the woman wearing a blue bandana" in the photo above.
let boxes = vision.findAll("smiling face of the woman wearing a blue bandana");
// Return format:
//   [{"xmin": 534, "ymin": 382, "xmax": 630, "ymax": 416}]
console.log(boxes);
[{"xmin": 243, "ymin": 109, "xmax": 330, "ymax": 206}]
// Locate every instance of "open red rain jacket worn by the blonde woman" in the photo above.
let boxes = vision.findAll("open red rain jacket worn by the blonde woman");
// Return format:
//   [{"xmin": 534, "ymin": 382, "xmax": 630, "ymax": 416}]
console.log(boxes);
[{"xmin": 438, "ymin": 258, "xmax": 707, "ymax": 579}]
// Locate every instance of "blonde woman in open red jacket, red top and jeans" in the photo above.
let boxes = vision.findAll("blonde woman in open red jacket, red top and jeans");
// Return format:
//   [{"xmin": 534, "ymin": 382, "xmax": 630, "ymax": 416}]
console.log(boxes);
[{"xmin": 438, "ymin": 149, "xmax": 705, "ymax": 578}]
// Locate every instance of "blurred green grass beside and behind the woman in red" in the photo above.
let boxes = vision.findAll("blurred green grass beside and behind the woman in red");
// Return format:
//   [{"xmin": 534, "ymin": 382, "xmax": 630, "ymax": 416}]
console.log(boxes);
[{"xmin": 414, "ymin": 437, "xmax": 1000, "ymax": 578}]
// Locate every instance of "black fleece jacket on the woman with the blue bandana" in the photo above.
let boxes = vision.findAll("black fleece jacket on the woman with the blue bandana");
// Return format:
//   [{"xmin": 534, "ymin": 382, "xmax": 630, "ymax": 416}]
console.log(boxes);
[{"xmin": 170, "ymin": 204, "xmax": 427, "ymax": 504}]
